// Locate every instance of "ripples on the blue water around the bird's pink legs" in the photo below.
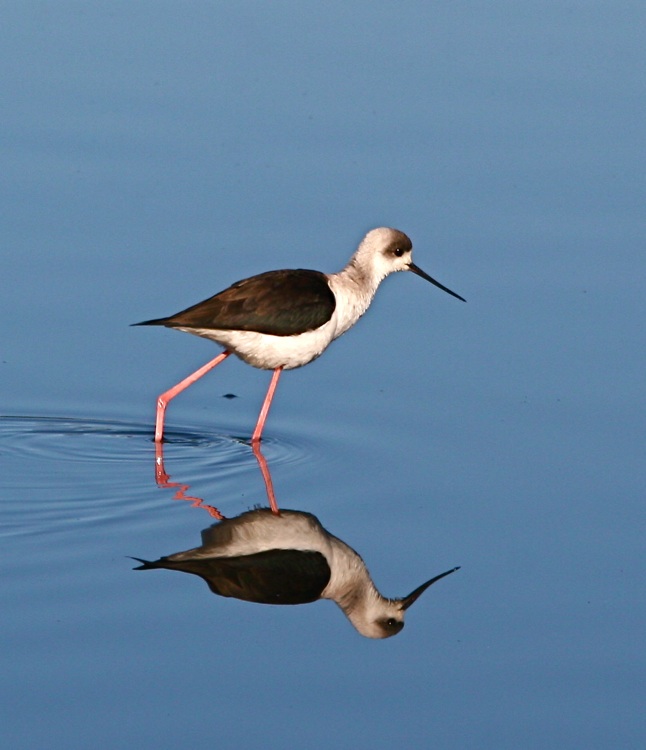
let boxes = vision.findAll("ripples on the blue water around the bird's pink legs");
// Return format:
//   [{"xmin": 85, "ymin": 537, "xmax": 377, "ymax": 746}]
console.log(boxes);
[{"xmin": 0, "ymin": 416, "xmax": 332, "ymax": 536}]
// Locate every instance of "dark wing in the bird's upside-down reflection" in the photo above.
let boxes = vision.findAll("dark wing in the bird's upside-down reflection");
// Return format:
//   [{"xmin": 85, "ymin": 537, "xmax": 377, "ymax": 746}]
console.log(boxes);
[{"xmin": 136, "ymin": 549, "xmax": 330, "ymax": 604}]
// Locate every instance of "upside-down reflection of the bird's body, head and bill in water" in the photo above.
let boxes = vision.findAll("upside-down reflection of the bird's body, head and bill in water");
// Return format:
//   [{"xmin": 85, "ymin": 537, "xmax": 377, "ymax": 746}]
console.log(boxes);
[{"xmin": 131, "ymin": 508, "xmax": 459, "ymax": 638}]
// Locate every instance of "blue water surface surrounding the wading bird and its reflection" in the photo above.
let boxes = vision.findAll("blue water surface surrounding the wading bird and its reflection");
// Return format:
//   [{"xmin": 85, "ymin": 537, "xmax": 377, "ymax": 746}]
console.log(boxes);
[{"xmin": 0, "ymin": 2, "xmax": 646, "ymax": 750}]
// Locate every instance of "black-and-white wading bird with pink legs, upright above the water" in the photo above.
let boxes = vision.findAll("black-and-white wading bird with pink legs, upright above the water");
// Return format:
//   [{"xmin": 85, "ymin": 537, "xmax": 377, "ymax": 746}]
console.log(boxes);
[{"xmin": 132, "ymin": 227, "xmax": 466, "ymax": 443}]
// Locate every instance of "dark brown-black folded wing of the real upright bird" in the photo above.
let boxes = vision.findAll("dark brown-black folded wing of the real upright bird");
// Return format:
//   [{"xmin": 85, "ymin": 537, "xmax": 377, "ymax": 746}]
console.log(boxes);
[{"xmin": 136, "ymin": 269, "xmax": 336, "ymax": 336}]
